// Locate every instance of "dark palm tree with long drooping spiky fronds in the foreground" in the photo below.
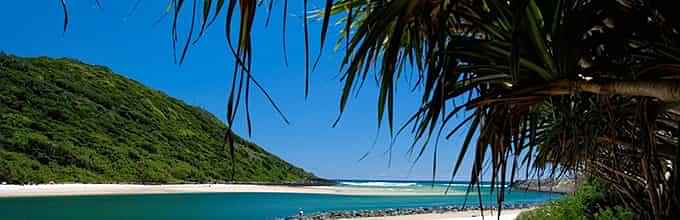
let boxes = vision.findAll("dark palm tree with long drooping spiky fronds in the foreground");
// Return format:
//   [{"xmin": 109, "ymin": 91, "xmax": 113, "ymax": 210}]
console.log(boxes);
[{"xmin": 62, "ymin": 0, "xmax": 680, "ymax": 218}]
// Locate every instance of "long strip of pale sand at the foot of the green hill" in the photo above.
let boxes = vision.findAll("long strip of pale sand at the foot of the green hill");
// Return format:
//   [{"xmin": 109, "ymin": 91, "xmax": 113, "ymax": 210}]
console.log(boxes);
[{"xmin": 0, "ymin": 183, "xmax": 468, "ymax": 198}]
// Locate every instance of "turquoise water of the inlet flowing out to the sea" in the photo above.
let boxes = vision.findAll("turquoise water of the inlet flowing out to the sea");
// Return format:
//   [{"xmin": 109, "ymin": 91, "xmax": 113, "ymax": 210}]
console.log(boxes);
[{"xmin": 0, "ymin": 181, "xmax": 559, "ymax": 220}]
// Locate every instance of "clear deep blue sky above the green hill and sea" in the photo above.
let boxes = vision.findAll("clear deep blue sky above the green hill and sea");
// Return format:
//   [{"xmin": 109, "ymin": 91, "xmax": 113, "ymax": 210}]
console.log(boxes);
[{"xmin": 0, "ymin": 0, "xmax": 480, "ymax": 180}]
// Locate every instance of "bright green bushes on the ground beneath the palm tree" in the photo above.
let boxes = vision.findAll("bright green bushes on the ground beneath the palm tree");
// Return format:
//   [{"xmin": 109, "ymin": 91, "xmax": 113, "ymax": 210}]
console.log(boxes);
[{"xmin": 517, "ymin": 180, "xmax": 633, "ymax": 220}]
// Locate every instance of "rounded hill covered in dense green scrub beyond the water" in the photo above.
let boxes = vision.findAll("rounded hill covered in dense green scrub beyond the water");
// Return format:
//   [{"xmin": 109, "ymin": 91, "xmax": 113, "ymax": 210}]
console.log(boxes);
[{"xmin": 0, "ymin": 54, "xmax": 313, "ymax": 183}]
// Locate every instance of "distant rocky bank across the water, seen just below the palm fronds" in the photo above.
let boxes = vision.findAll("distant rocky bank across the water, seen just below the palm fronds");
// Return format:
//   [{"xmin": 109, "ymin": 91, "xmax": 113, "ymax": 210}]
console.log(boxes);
[{"xmin": 512, "ymin": 179, "xmax": 576, "ymax": 193}]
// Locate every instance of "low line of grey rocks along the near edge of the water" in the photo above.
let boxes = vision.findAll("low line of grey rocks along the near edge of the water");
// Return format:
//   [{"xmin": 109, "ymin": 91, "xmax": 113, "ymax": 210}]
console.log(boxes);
[{"xmin": 281, "ymin": 203, "xmax": 538, "ymax": 220}]
